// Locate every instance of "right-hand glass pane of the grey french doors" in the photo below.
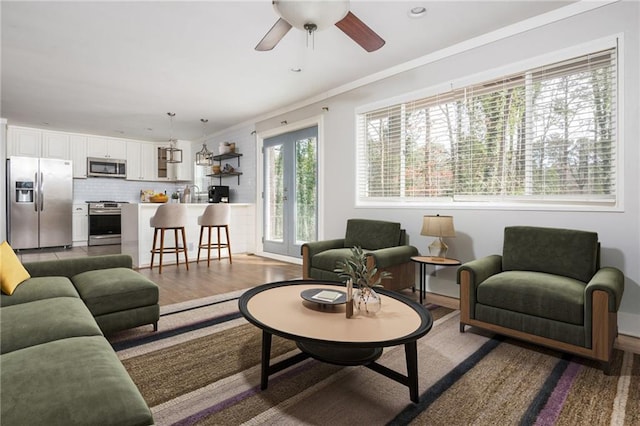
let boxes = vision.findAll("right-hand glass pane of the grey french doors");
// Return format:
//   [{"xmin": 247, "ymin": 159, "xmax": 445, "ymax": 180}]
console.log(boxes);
[{"xmin": 295, "ymin": 138, "xmax": 317, "ymax": 245}]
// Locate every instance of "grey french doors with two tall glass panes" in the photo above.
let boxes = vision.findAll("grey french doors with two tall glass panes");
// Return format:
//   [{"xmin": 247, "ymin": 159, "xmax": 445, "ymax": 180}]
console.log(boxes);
[{"xmin": 263, "ymin": 126, "xmax": 318, "ymax": 257}]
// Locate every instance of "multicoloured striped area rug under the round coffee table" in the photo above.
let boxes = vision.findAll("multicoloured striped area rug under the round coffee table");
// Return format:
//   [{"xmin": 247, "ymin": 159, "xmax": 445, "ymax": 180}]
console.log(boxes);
[{"xmin": 110, "ymin": 292, "xmax": 640, "ymax": 426}]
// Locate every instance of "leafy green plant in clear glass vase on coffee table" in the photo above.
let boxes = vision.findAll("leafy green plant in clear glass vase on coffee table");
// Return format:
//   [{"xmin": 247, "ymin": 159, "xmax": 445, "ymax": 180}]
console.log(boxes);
[{"xmin": 334, "ymin": 246, "xmax": 391, "ymax": 315}]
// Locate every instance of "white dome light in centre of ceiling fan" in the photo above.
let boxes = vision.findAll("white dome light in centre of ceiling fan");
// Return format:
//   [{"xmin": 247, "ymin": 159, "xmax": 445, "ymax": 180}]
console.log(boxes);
[{"xmin": 273, "ymin": 0, "xmax": 349, "ymax": 30}]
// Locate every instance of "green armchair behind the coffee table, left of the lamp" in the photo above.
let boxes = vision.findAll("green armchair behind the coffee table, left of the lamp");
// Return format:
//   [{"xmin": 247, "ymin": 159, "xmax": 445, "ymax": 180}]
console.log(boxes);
[{"xmin": 302, "ymin": 219, "xmax": 418, "ymax": 290}]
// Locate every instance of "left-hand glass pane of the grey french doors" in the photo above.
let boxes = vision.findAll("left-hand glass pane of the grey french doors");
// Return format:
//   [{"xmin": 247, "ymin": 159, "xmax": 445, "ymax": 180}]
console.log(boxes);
[{"xmin": 264, "ymin": 145, "xmax": 285, "ymax": 242}]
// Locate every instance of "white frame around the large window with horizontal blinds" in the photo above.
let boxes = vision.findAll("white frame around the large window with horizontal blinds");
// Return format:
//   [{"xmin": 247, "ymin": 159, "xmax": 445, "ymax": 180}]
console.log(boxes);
[{"xmin": 355, "ymin": 34, "xmax": 624, "ymax": 212}]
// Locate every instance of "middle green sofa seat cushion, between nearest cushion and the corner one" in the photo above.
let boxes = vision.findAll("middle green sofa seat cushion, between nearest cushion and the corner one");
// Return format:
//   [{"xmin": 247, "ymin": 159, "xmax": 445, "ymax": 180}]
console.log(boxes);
[{"xmin": 0, "ymin": 297, "xmax": 102, "ymax": 354}]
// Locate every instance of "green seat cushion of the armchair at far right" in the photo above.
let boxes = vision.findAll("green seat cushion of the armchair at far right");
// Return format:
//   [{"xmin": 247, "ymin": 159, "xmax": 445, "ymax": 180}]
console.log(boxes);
[{"xmin": 477, "ymin": 271, "xmax": 585, "ymax": 325}]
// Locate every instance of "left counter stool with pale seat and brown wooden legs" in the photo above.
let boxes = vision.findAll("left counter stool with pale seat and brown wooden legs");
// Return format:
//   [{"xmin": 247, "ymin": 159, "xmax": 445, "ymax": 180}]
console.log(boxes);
[{"xmin": 150, "ymin": 204, "xmax": 189, "ymax": 274}]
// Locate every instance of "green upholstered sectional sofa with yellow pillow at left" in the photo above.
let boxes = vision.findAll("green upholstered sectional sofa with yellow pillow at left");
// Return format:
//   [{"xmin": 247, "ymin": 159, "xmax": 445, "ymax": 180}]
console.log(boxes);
[{"xmin": 0, "ymin": 255, "xmax": 159, "ymax": 425}]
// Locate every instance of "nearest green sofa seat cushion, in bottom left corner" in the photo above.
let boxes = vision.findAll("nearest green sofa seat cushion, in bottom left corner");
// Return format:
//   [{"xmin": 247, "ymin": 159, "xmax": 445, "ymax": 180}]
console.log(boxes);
[{"xmin": 0, "ymin": 336, "xmax": 153, "ymax": 426}]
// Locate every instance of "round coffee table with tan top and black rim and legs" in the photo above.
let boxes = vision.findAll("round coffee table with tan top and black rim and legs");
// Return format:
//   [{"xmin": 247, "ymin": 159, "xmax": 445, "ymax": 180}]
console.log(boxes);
[{"xmin": 238, "ymin": 280, "xmax": 433, "ymax": 403}]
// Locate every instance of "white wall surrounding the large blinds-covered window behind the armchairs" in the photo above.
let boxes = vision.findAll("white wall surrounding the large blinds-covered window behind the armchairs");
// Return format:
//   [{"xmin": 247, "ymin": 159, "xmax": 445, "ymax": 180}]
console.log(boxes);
[{"xmin": 256, "ymin": 1, "xmax": 640, "ymax": 336}]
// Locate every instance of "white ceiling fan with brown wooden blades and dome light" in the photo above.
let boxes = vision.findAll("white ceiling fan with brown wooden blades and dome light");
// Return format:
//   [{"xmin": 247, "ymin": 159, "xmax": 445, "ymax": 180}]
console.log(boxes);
[{"xmin": 256, "ymin": 0, "xmax": 385, "ymax": 52}]
